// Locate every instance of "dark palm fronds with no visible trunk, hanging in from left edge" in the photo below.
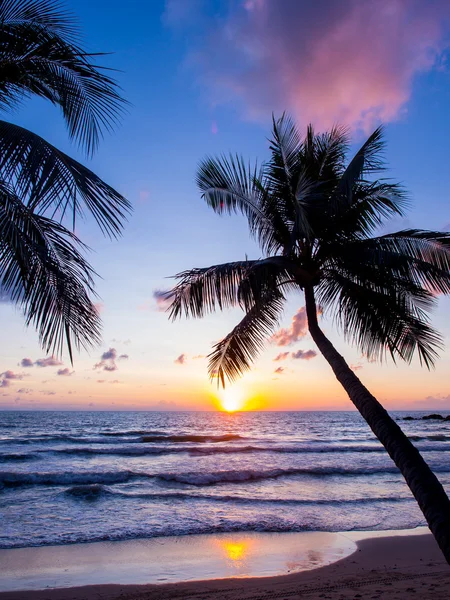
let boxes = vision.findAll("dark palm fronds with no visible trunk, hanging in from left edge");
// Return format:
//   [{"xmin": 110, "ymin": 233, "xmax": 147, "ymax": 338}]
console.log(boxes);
[{"xmin": 0, "ymin": 0, "xmax": 130, "ymax": 360}]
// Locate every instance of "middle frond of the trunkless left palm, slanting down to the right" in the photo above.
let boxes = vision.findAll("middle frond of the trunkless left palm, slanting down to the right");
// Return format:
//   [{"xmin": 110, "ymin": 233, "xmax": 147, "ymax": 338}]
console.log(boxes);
[{"xmin": 0, "ymin": 121, "xmax": 131, "ymax": 237}]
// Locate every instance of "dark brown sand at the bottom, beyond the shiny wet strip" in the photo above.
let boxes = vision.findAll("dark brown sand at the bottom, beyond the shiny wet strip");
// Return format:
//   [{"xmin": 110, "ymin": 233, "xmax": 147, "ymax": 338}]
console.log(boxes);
[{"xmin": 0, "ymin": 534, "xmax": 450, "ymax": 600}]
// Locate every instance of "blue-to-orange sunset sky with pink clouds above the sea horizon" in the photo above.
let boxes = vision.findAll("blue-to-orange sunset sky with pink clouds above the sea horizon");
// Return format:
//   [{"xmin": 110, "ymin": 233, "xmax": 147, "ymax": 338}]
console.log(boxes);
[{"xmin": 0, "ymin": 0, "xmax": 450, "ymax": 410}]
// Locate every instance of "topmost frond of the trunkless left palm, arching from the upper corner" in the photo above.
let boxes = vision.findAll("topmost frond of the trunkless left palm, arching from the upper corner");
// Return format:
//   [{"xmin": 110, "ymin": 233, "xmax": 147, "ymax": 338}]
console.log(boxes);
[{"xmin": 0, "ymin": 0, "xmax": 126, "ymax": 155}]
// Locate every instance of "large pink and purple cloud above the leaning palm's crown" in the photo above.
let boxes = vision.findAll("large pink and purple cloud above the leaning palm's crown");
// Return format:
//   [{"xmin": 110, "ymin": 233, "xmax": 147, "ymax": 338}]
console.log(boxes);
[{"xmin": 170, "ymin": 0, "xmax": 450, "ymax": 130}]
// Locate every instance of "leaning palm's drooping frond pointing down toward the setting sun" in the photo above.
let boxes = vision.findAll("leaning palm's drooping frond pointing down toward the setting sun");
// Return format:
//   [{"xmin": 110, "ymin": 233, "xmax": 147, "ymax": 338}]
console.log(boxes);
[{"xmin": 208, "ymin": 290, "xmax": 285, "ymax": 387}]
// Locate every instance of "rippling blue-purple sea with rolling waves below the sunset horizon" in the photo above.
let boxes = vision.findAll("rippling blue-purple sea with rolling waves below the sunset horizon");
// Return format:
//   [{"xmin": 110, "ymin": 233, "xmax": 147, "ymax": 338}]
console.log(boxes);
[{"xmin": 0, "ymin": 411, "xmax": 450, "ymax": 548}]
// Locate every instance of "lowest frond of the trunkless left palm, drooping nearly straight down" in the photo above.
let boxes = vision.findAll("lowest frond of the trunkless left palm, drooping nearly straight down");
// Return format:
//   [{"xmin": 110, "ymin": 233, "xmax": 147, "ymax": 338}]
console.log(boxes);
[{"xmin": 0, "ymin": 183, "xmax": 100, "ymax": 360}]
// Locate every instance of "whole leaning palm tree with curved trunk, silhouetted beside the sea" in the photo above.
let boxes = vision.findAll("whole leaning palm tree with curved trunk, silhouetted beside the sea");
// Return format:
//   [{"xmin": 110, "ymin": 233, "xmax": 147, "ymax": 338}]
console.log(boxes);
[{"xmin": 168, "ymin": 116, "xmax": 450, "ymax": 563}]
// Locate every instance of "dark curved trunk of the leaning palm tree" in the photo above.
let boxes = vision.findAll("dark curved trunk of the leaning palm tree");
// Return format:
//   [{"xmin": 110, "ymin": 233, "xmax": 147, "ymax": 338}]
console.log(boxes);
[{"xmin": 305, "ymin": 287, "xmax": 450, "ymax": 564}]
